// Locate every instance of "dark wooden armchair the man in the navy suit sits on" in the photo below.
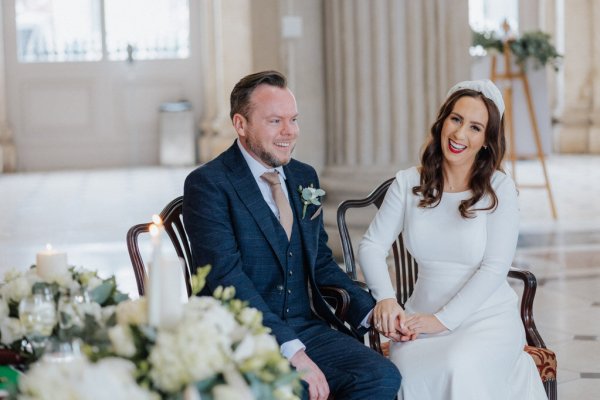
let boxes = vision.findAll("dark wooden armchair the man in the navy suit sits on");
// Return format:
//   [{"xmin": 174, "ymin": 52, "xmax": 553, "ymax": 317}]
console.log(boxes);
[{"xmin": 127, "ymin": 196, "xmax": 350, "ymax": 319}]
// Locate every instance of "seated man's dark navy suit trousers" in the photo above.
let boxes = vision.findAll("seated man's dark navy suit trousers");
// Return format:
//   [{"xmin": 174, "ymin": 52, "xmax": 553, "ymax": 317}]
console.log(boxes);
[{"xmin": 293, "ymin": 320, "xmax": 401, "ymax": 400}]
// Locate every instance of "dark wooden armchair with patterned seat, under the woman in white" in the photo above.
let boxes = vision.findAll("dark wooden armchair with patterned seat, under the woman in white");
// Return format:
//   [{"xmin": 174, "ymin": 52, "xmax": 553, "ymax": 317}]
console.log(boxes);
[{"xmin": 337, "ymin": 178, "xmax": 557, "ymax": 400}]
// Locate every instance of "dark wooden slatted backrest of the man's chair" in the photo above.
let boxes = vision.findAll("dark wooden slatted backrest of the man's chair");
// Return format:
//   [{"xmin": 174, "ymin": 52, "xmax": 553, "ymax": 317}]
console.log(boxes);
[{"xmin": 127, "ymin": 196, "xmax": 192, "ymax": 296}]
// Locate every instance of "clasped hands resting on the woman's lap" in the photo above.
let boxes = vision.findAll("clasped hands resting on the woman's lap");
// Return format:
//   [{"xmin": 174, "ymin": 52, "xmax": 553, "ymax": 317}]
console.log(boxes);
[{"xmin": 373, "ymin": 298, "xmax": 447, "ymax": 342}]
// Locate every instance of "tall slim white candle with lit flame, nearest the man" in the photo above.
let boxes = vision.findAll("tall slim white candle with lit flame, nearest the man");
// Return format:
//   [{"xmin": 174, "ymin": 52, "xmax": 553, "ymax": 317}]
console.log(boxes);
[{"xmin": 146, "ymin": 215, "xmax": 164, "ymax": 327}]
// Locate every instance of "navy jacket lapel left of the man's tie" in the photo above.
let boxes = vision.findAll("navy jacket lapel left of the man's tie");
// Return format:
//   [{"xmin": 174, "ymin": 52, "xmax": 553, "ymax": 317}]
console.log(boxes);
[{"xmin": 224, "ymin": 143, "xmax": 287, "ymax": 268}]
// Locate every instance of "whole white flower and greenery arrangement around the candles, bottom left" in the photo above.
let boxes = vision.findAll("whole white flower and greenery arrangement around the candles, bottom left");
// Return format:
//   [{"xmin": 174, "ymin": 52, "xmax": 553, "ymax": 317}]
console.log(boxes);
[{"xmin": 0, "ymin": 267, "xmax": 300, "ymax": 400}]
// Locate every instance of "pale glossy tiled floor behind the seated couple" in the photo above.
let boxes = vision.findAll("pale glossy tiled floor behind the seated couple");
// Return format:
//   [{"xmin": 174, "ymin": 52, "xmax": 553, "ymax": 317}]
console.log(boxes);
[{"xmin": 0, "ymin": 156, "xmax": 600, "ymax": 400}]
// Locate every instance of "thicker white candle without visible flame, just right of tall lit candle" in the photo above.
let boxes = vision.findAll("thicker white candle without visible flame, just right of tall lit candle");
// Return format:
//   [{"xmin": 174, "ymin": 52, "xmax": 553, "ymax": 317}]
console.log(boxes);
[{"xmin": 159, "ymin": 258, "xmax": 183, "ymax": 329}]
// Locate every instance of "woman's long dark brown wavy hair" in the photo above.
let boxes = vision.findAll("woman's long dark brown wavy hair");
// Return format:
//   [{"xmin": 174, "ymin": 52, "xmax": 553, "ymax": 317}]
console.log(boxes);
[{"xmin": 412, "ymin": 89, "xmax": 506, "ymax": 218}]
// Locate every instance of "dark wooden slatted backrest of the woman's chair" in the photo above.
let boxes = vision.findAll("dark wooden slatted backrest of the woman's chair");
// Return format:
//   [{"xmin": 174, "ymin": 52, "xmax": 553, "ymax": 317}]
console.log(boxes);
[{"xmin": 337, "ymin": 178, "xmax": 419, "ymax": 307}]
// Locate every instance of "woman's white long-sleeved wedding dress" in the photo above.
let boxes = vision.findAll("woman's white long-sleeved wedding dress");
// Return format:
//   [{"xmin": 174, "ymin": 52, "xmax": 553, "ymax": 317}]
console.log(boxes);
[{"xmin": 359, "ymin": 167, "xmax": 546, "ymax": 400}]
